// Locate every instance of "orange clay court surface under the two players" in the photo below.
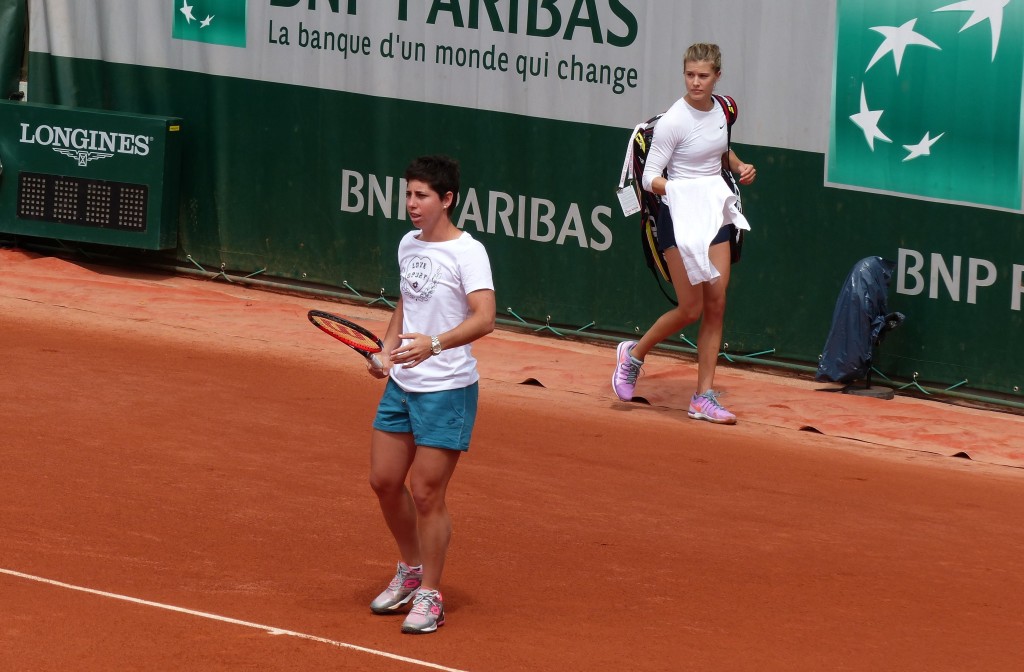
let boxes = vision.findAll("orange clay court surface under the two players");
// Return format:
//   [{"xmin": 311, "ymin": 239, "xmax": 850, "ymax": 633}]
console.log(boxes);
[{"xmin": 0, "ymin": 249, "xmax": 1024, "ymax": 672}]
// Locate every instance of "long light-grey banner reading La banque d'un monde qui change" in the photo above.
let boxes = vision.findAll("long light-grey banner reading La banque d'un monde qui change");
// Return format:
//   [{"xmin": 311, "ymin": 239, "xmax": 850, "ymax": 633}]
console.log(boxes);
[{"xmin": 30, "ymin": 0, "xmax": 834, "ymax": 153}]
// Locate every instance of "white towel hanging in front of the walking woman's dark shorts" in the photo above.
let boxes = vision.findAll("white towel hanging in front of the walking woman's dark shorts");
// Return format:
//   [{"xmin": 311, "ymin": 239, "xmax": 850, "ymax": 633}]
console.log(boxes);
[{"xmin": 665, "ymin": 175, "xmax": 751, "ymax": 285}]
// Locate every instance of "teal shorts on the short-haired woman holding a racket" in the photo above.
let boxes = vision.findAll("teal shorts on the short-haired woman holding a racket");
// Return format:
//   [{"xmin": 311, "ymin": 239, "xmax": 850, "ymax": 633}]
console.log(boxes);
[{"xmin": 374, "ymin": 379, "xmax": 480, "ymax": 451}]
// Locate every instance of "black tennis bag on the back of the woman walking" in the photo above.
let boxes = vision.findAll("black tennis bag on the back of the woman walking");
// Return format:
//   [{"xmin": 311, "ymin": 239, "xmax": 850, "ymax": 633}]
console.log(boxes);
[{"xmin": 622, "ymin": 95, "xmax": 742, "ymax": 305}]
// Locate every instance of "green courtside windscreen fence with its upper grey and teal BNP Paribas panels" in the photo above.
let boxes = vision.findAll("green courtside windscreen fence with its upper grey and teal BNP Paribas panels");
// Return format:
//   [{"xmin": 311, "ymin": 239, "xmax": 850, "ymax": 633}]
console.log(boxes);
[{"xmin": 15, "ymin": 0, "xmax": 1024, "ymax": 401}]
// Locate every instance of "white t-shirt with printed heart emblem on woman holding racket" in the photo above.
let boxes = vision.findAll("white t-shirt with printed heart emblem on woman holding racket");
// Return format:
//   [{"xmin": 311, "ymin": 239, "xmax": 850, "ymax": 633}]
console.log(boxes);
[{"xmin": 391, "ymin": 229, "xmax": 495, "ymax": 392}]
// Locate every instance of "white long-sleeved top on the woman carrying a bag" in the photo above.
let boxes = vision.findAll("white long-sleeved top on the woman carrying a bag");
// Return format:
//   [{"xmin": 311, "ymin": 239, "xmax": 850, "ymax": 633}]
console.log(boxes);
[{"xmin": 643, "ymin": 98, "xmax": 729, "ymax": 202}]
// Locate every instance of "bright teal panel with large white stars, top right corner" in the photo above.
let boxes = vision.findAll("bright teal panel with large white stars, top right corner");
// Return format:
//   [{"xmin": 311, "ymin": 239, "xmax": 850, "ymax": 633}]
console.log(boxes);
[{"xmin": 827, "ymin": 0, "xmax": 1024, "ymax": 212}]
